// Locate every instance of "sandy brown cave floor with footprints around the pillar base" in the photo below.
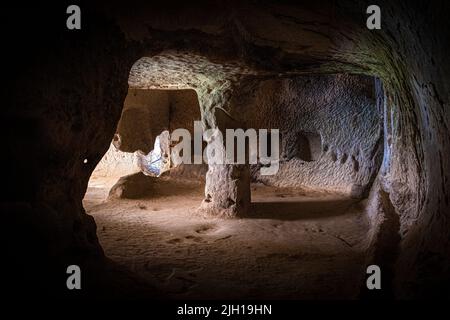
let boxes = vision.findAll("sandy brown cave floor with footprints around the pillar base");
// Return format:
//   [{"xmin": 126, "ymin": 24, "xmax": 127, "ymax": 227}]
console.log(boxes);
[{"xmin": 84, "ymin": 178, "xmax": 367, "ymax": 299}]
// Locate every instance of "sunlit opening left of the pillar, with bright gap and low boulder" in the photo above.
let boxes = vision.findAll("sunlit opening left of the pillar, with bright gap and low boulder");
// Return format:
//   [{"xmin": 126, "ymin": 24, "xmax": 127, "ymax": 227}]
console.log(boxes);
[{"xmin": 84, "ymin": 88, "xmax": 207, "ymax": 208}]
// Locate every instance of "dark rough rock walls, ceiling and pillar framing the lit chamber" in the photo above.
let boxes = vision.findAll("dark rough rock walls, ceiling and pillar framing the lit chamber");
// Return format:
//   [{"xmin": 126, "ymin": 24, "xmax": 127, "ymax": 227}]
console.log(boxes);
[{"xmin": 2, "ymin": 0, "xmax": 450, "ymax": 297}]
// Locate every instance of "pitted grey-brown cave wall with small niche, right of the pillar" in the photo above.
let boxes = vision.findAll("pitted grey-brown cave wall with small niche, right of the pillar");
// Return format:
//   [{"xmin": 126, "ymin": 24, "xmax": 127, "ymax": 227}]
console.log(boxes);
[{"xmin": 230, "ymin": 74, "xmax": 383, "ymax": 197}]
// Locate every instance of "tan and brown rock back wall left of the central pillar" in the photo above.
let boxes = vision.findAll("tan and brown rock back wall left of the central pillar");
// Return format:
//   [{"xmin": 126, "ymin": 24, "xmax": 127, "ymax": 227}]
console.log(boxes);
[{"xmin": 101, "ymin": 88, "xmax": 206, "ymax": 198}]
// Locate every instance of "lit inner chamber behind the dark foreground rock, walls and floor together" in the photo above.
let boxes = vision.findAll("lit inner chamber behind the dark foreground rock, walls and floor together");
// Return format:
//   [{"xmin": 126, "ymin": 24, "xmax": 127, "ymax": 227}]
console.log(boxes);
[{"xmin": 84, "ymin": 74, "xmax": 383, "ymax": 298}]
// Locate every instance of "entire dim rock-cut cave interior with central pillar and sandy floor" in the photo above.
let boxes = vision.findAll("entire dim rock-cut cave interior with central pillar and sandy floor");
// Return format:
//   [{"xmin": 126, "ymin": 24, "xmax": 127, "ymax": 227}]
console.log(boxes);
[{"xmin": 2, "ymin": 0, "xmax": 450, "ymax": 299}]
